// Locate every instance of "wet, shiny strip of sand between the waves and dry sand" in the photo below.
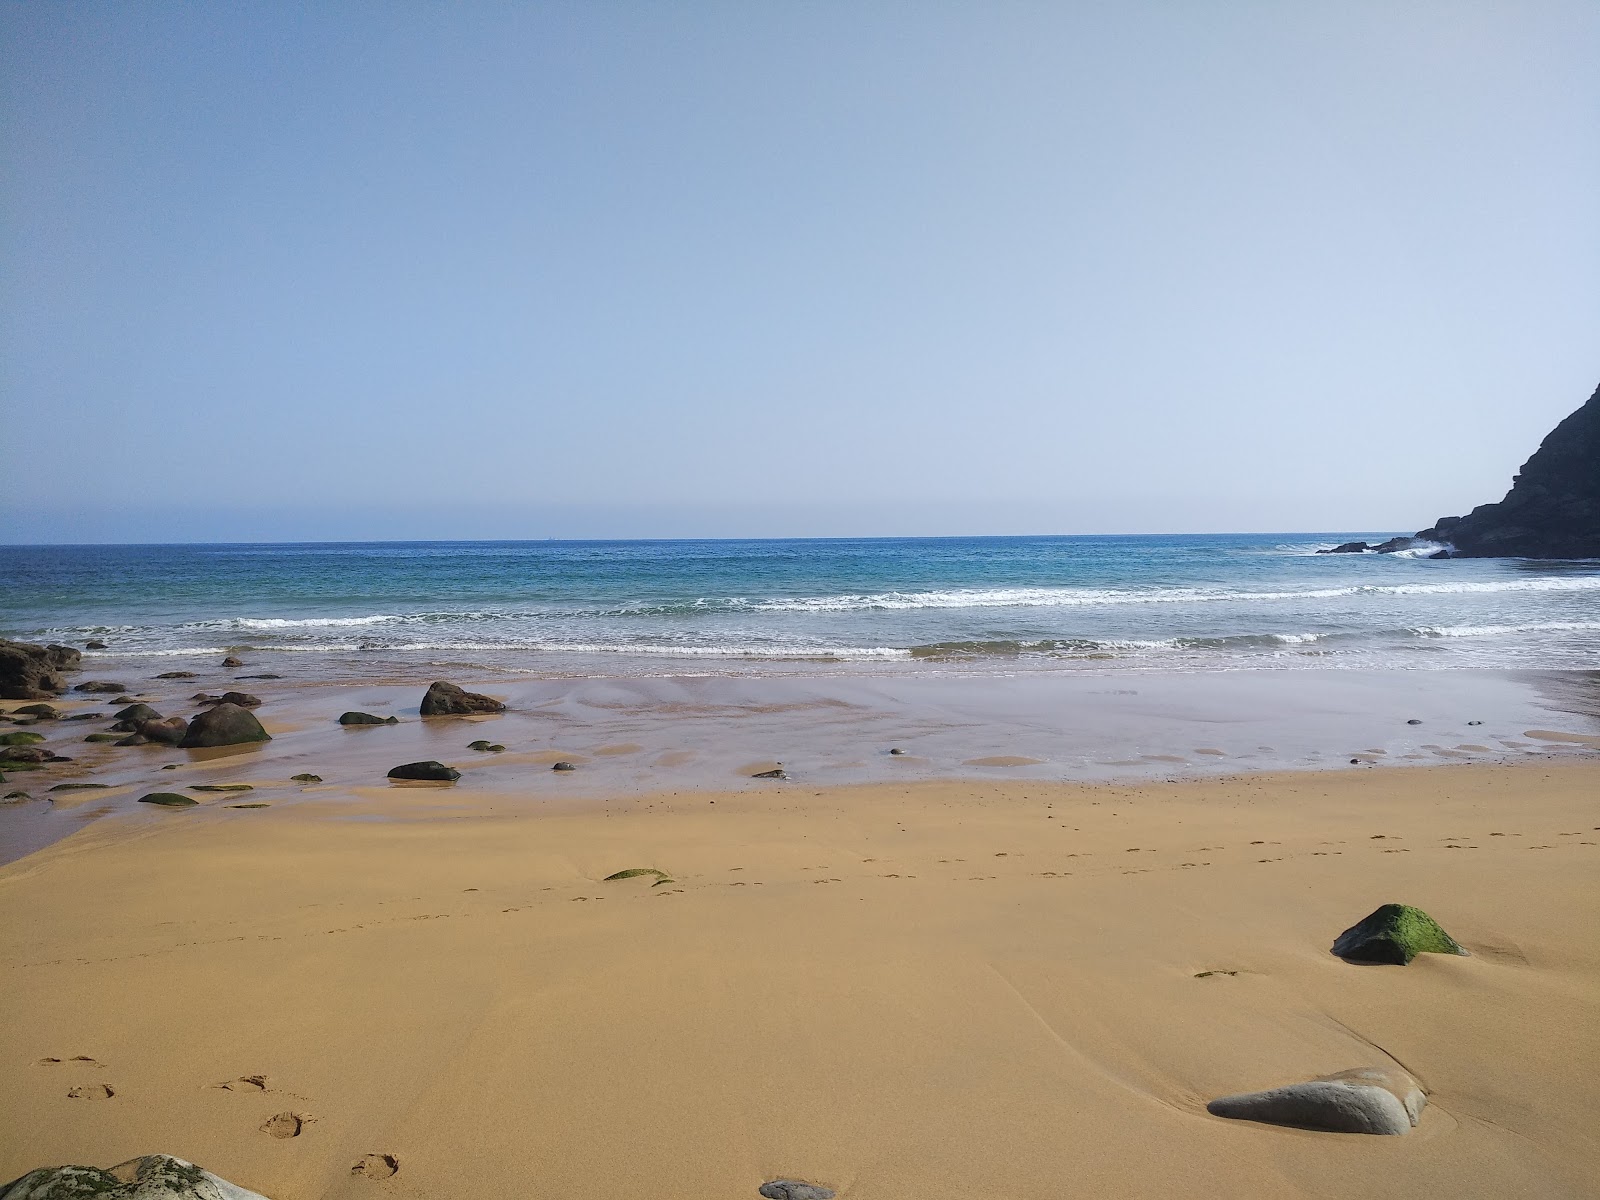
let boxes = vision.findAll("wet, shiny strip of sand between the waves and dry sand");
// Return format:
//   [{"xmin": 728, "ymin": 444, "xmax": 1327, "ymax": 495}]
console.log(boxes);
[{"xmin": 0, "ymin": 667, "xmax": 1600, "ymax": 862}]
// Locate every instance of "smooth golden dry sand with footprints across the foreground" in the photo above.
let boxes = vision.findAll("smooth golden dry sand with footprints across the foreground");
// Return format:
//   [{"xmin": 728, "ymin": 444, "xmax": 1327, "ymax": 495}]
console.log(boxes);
[{"xmin": 0, "ymin": 763, "xmax": 1600, "ymax": 1200}]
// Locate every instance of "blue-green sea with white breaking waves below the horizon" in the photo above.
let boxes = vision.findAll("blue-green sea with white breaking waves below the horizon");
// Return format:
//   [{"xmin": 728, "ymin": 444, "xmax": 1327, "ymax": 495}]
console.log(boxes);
[{"xmin": 0, "ymin": 531, "xmax": 1600, "ymax": 678}]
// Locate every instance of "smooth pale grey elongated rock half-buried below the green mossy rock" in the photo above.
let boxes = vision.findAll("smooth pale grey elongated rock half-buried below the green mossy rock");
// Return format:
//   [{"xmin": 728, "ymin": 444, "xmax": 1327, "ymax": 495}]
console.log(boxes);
[{"xmin": 1205, "ymin": 1067, "xmax": 1427, "ymax": 1134}]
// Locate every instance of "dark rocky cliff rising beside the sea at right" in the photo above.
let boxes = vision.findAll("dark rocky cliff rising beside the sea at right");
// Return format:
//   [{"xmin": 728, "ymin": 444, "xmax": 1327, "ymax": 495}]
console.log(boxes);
[{"xmin": 1416, "ymin": 387, "xmax": 1600, "ymax": 558}]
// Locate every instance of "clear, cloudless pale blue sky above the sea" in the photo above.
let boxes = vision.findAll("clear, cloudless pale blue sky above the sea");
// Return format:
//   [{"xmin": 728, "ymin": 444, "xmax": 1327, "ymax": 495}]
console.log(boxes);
[{"xmin": 0, "ymin": 0, "xmax": 1600, "ymax": 542}]
